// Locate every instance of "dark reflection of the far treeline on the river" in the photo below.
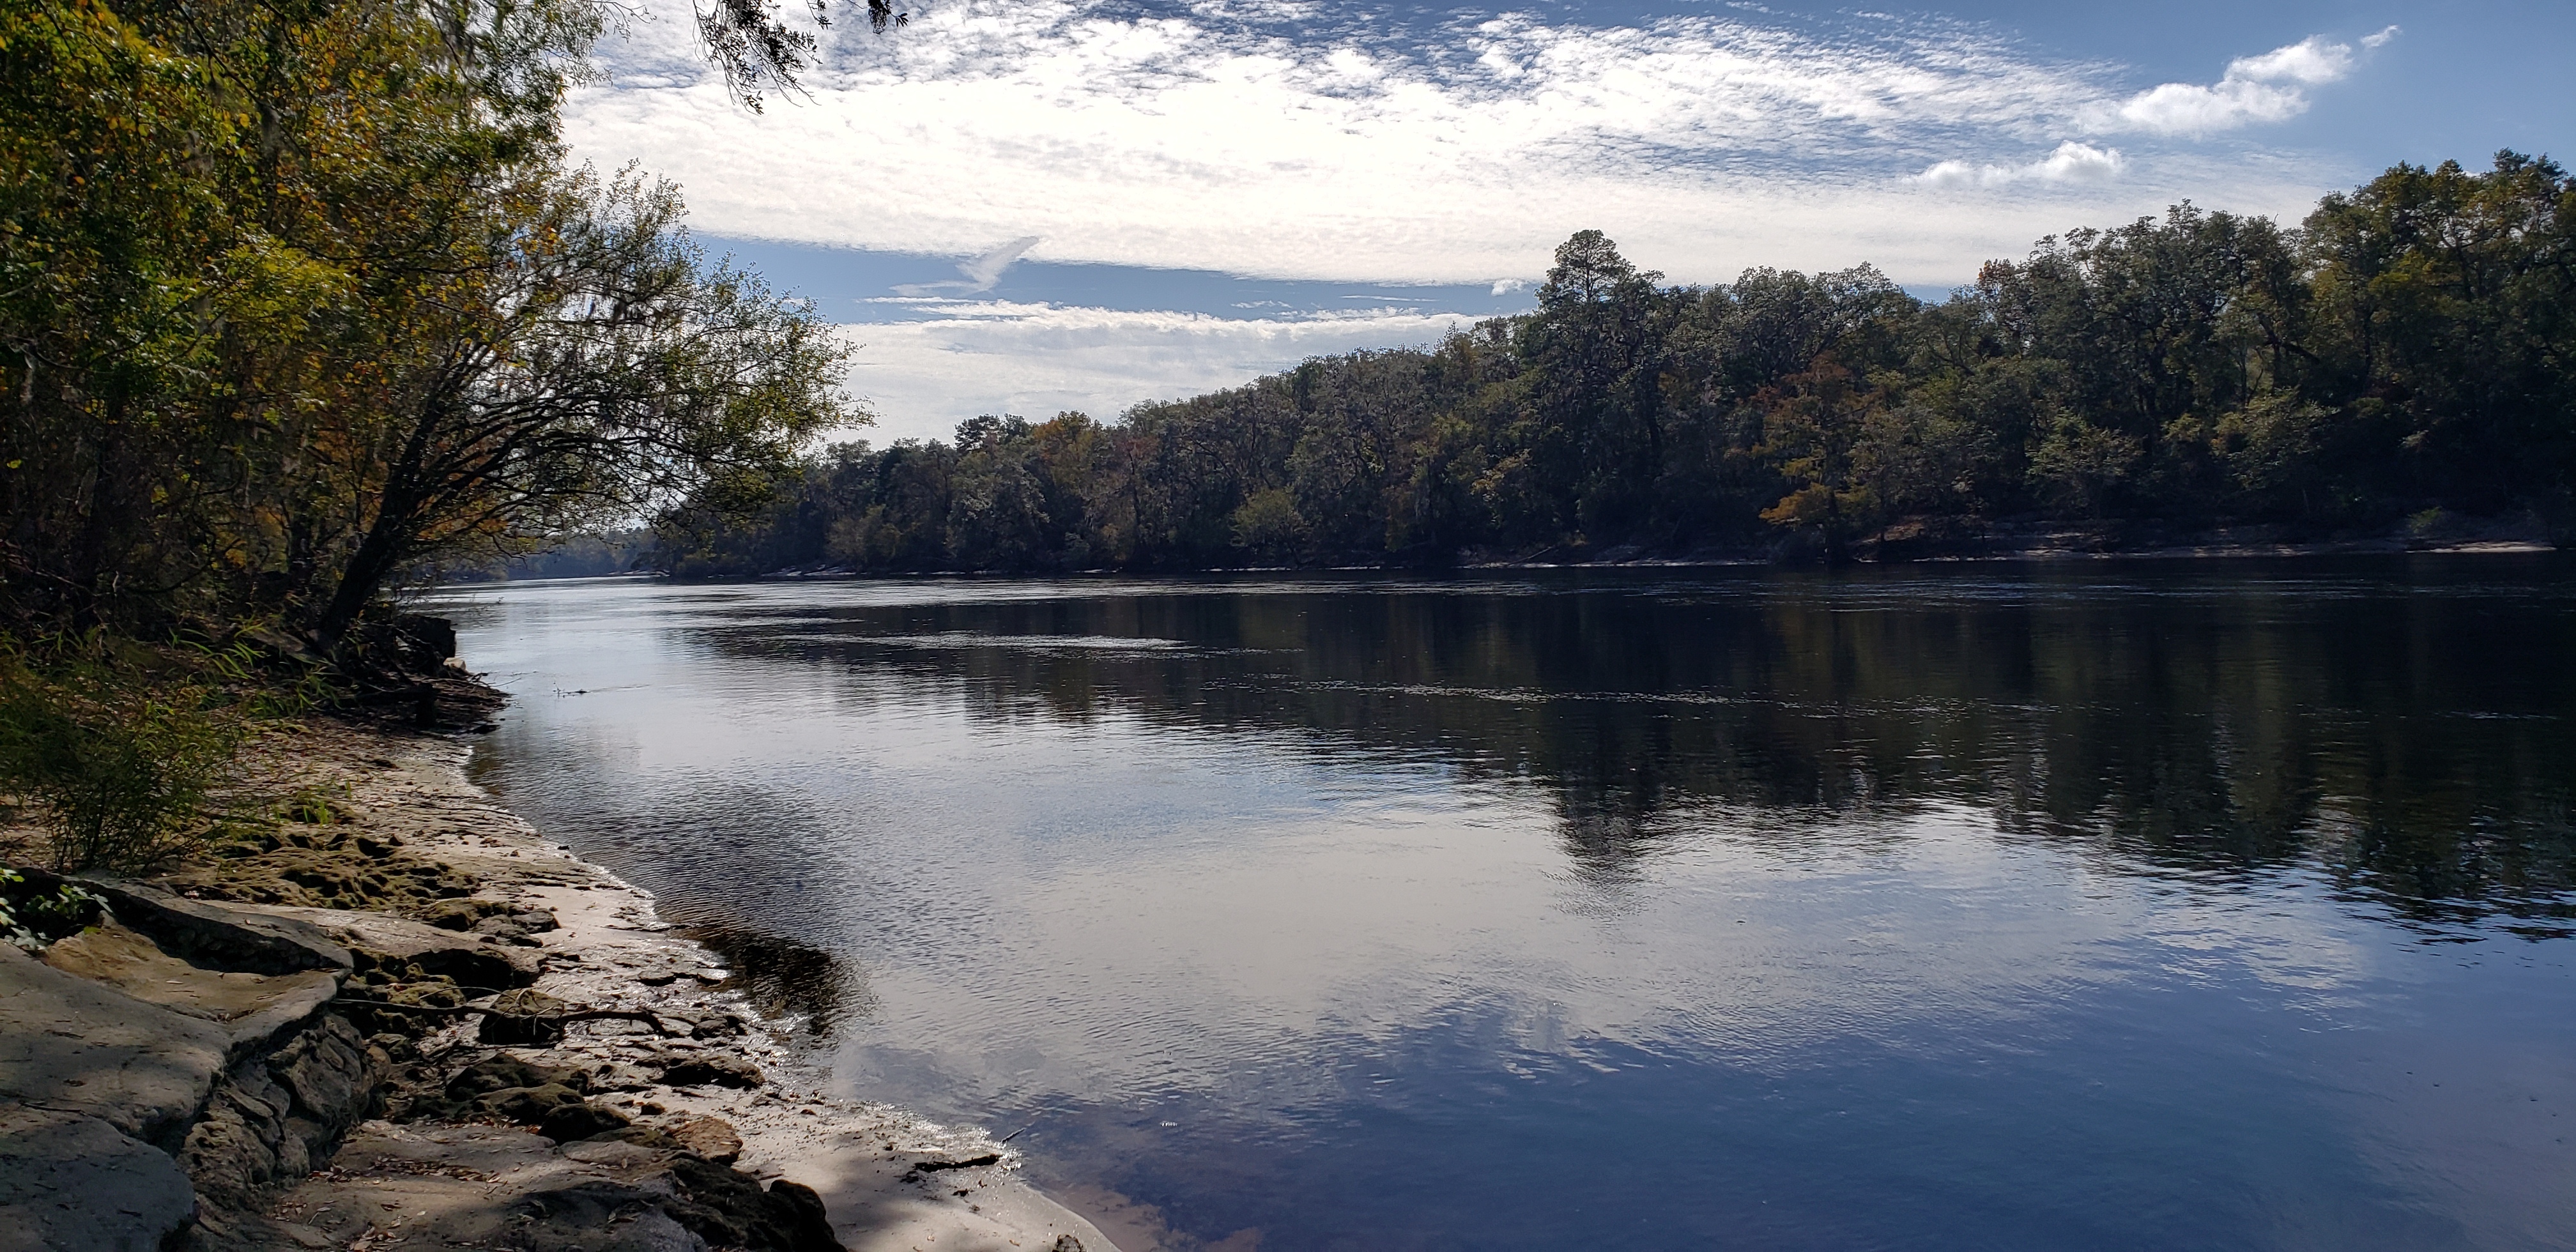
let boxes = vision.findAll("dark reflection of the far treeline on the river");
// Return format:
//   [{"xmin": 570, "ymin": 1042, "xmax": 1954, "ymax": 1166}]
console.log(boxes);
[{"xmin": 714, "ymin": 556, "xmax": 2576, "ymax": 935}]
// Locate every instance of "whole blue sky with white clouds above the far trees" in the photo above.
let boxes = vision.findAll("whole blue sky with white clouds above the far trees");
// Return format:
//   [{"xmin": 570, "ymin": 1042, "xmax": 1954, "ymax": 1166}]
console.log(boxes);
[{"xmin": 569, "ymin": 0, "xmax": 2576, "ymax": 441}]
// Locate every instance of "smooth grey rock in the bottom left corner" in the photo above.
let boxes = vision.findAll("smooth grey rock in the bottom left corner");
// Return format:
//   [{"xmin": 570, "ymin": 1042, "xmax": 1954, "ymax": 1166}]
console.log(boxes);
[{"xmin": 0, "ymin": 1105, "xmax": 195, "ymax": 1252}]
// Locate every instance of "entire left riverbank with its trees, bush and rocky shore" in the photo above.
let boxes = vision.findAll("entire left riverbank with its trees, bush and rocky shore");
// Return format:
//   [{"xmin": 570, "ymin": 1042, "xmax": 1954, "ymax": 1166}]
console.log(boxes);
[{"xmin": 0, "ymin": 0, "xmax": 1100, "ymax": 1252}]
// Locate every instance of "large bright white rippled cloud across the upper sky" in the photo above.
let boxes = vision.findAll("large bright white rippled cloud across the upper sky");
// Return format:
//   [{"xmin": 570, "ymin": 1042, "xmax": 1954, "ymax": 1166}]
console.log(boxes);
[{"xmin": 569, "ymin": 0, "xmax": 2321, "ymax": 284}]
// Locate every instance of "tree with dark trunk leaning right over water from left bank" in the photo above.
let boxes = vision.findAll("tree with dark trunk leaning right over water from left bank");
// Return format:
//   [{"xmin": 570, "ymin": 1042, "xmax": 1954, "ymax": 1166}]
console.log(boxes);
[{"xmin": 314, "ymin": 172, "xmax": 855, "ymax": 641}]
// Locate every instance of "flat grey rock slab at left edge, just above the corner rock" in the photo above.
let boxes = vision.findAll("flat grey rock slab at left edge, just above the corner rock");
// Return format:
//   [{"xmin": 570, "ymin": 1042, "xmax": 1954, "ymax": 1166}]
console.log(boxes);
[{"xmin": 0, "ymin": 943, "xmax": 232, "ymax": 1144}]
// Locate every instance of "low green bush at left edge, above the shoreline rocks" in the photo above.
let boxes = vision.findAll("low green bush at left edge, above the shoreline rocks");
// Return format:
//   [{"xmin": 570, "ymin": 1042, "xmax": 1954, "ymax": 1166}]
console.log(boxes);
[{"xmin": 0, "ymin": 636, "xmax": 263, "ymax": 871}]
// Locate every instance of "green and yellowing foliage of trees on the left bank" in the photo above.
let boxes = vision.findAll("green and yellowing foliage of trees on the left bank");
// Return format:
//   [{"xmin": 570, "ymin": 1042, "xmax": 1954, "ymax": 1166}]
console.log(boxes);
[{"xmin": 0, "ymin": 0, "xmax": 858, "ymax": 649}]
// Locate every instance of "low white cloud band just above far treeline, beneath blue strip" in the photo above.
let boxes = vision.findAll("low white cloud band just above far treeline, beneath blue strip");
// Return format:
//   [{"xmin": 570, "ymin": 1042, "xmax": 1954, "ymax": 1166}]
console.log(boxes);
[{"xmin": 842, "ymin": 299, "xmax": 1471, "ymax": 443}]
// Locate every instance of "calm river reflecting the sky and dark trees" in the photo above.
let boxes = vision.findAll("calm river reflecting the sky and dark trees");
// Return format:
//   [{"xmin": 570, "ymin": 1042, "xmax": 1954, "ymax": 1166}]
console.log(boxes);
[{"xmin": 433, "ymin": 556, "xmax": 2576, "ymax": 1252}]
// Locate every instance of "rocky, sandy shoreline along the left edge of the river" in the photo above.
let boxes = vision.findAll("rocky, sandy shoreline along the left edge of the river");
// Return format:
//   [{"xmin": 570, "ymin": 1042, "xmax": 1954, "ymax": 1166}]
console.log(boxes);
[{"xmin": 0, "ymin": 721, "xmax": 1113, "ymax": 1252}]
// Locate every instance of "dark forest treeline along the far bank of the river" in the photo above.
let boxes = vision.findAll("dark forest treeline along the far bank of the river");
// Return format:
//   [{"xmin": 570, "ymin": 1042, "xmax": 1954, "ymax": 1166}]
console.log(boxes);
[{"xmin": 654, "ymin": 152, "xmax": 2576, "ymax": 574}]
